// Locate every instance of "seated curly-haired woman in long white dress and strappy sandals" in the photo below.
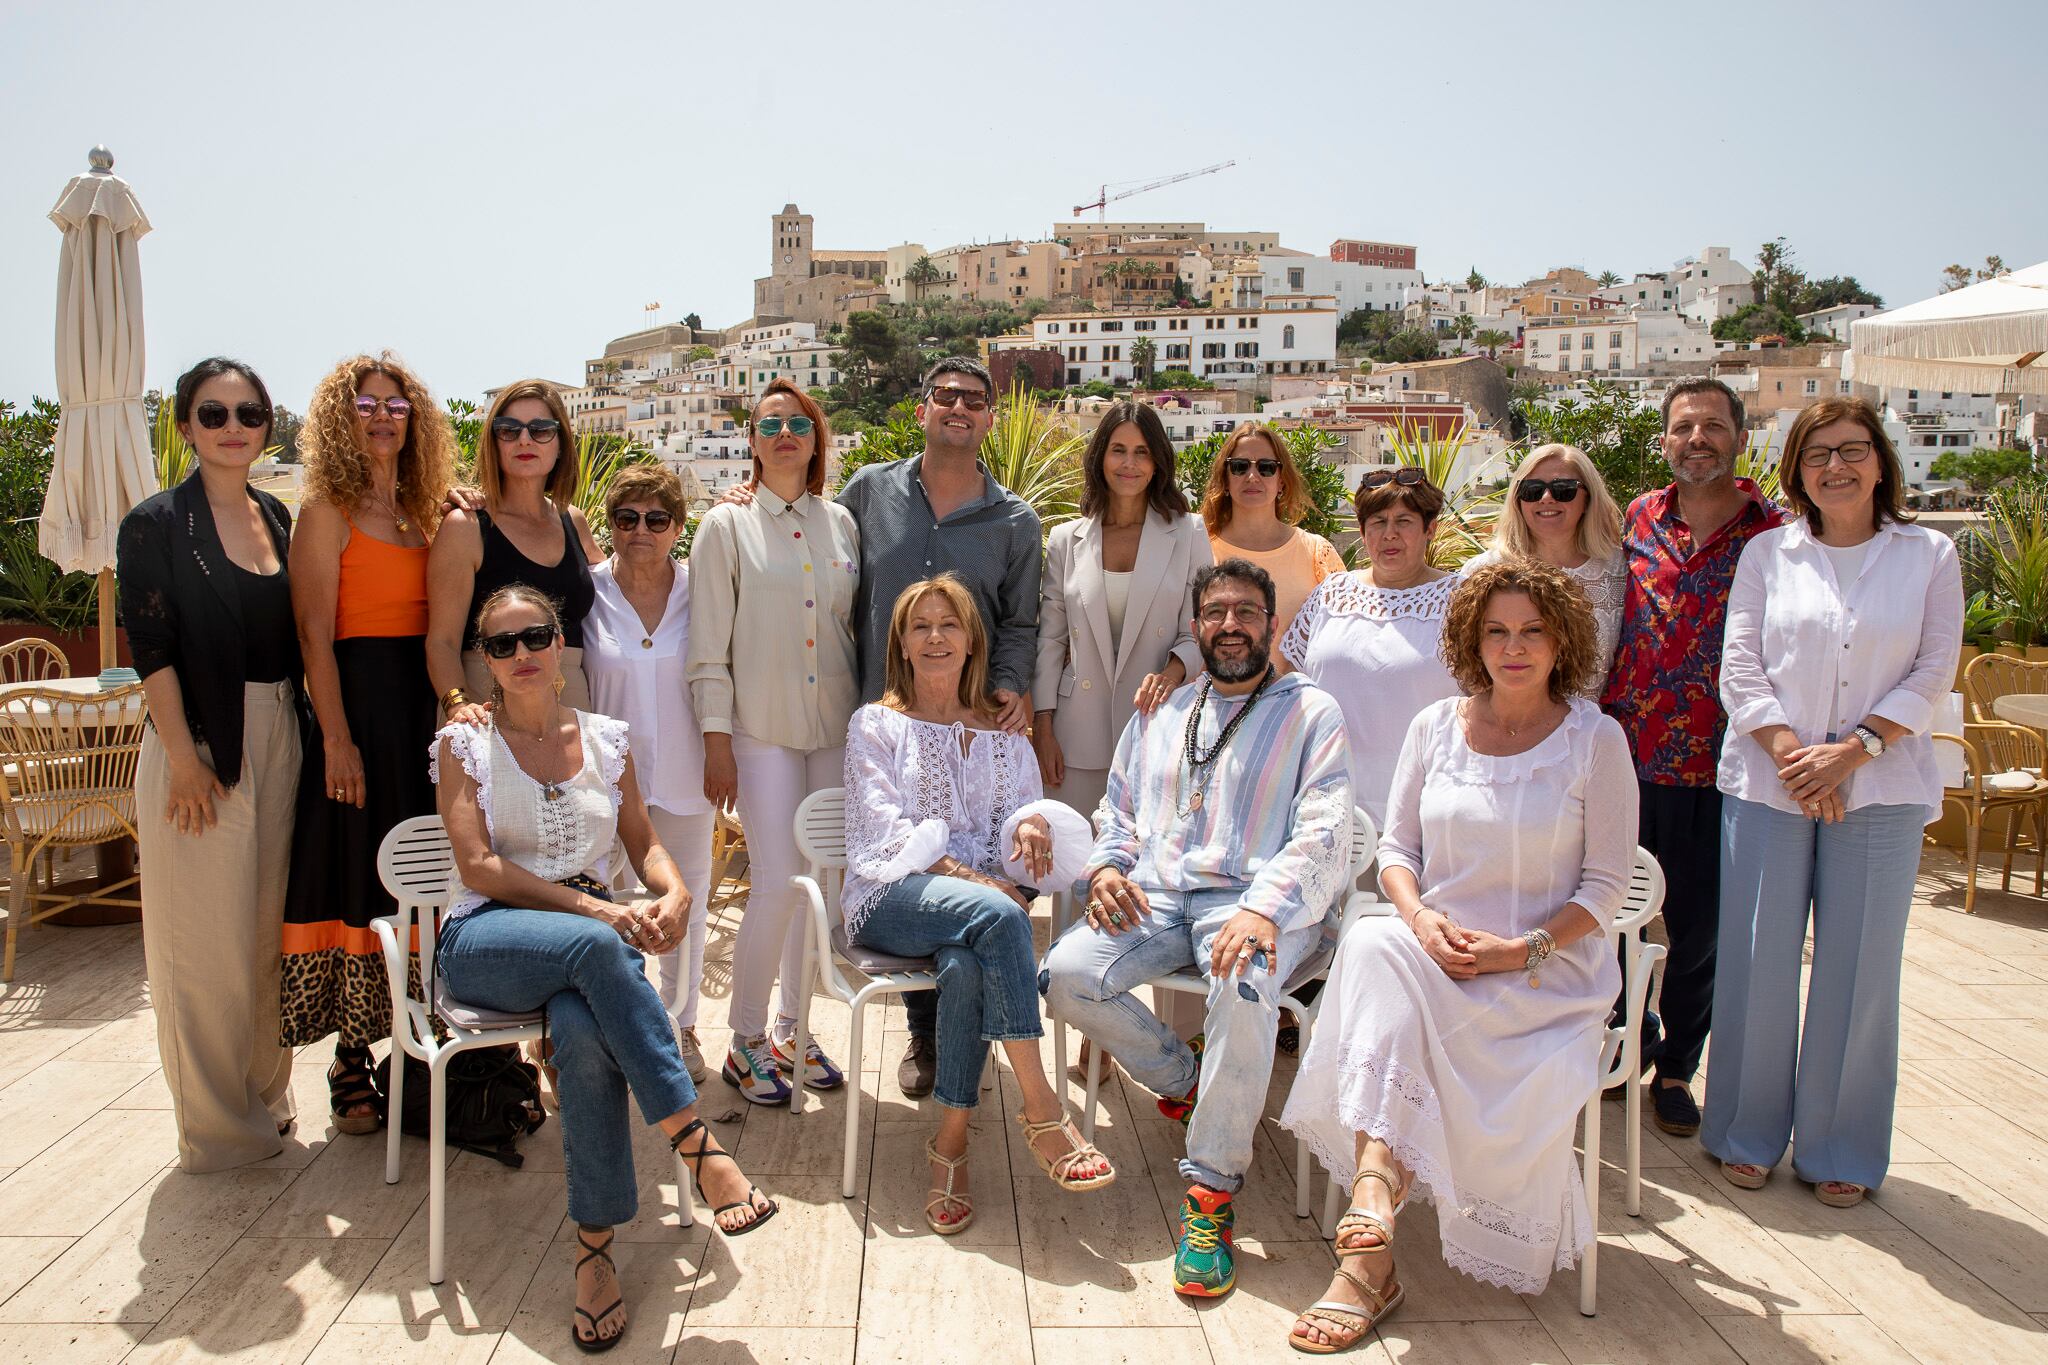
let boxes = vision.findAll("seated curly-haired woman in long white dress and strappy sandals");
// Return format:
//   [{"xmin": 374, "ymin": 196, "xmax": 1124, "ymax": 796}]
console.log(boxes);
[{"xmin": 1280, "ymin": 559, "xmax": 1636, "ymax": 1355}]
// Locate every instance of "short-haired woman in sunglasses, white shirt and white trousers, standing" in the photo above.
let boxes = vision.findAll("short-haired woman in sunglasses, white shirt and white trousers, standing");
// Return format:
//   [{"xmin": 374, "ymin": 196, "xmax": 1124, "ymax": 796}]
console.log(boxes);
[{"xmin": 584, "ymin": 460, "xmax": 717, "ymax": 1085}]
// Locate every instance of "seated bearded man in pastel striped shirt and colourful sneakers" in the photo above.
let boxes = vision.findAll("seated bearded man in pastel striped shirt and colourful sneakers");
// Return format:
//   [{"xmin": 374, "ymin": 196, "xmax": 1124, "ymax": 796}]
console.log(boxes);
[{"xmin": 1038, "ymin": 559, "xmax": 1352, "ymax": 1297}]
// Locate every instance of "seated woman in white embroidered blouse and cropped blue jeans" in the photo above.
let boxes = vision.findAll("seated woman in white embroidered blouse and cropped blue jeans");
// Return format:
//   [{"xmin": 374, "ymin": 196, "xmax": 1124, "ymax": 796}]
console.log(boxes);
[{"xmin": 842, "ymin": 573, "xmax": 1116, "ymax": 1236}]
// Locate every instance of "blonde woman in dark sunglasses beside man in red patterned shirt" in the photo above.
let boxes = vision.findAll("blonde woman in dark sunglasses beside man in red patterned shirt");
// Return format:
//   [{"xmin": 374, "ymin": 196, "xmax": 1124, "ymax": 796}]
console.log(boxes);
[{"xmin": 1462, "ymin": 444, "xmax": 1628, "ymax": 700}]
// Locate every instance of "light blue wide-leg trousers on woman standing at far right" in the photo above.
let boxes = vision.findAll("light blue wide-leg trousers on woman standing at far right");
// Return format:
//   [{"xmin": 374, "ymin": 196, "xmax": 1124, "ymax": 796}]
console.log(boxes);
[{"xmin": 1700, "ymin": 796, "xmax": 1927, "ymax": 1187}]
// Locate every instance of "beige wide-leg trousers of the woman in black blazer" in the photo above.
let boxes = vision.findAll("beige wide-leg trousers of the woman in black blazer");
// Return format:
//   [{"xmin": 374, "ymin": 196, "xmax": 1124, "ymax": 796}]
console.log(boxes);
[{"xmin": 135, "ymin": 684, "xmax": 299, "ymax": 1171}]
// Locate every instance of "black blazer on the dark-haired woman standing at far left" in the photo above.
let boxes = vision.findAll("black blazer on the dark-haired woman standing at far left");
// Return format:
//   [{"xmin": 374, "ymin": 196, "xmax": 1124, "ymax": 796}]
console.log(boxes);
[{"xmin": 115, "ymin": 471, "xmax": 305, "ymax": 786}]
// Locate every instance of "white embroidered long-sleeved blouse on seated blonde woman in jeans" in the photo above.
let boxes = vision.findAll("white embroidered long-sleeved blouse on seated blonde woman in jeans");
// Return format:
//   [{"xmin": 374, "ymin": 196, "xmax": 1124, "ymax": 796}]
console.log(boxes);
[{"xmin": 840, "ymin": 704, "xmax": 1096, "ymax": 933}]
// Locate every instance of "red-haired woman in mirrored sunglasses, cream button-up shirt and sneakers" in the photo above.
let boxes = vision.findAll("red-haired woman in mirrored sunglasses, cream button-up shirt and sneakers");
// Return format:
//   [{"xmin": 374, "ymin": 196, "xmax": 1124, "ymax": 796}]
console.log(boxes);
[{"xmin": 688, "ymin": 379, "xmax": 860, "ymax": 1105}]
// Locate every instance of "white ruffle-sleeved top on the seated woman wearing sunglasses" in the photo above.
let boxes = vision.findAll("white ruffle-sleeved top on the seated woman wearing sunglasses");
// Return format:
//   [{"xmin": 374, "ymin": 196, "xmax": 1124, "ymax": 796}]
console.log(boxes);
[{"xmin": 428, "ymin": 710, "xmax": 627, "ymax": 923}]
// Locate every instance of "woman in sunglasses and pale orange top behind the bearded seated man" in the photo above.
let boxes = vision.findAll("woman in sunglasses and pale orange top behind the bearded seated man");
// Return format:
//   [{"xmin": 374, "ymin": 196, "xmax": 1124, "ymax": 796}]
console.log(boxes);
[{"xmin": 1202, "ymin": 422, "xmax": 1343, "ymax": 673}]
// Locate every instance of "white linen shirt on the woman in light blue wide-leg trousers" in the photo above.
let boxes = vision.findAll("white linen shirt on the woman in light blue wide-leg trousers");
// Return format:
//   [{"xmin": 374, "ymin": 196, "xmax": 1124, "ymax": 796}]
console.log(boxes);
[{"xmin": 1718, "ymin": 520, "xmax": 1962, "ymax": 821}]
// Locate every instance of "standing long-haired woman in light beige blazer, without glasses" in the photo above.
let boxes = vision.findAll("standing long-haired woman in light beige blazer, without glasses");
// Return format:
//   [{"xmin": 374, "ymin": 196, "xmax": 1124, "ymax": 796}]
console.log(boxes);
[{"xmin": 1032, "ymin": 399, "xmax": 1210, "ymax": 819}]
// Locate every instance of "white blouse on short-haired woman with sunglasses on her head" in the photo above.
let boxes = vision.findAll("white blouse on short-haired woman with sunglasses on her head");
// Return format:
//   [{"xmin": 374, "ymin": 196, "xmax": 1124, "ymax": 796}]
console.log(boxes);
[{"xmin": 1280, "ymin": 571, "xmax": 1458, "ymax": 827}]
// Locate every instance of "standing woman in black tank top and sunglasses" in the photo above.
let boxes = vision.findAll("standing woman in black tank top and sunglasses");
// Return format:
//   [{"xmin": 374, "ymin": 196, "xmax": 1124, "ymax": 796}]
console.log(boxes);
[{"xmin": 426, "ymin": 379, "xmax": 604, "ymax": 724}]
